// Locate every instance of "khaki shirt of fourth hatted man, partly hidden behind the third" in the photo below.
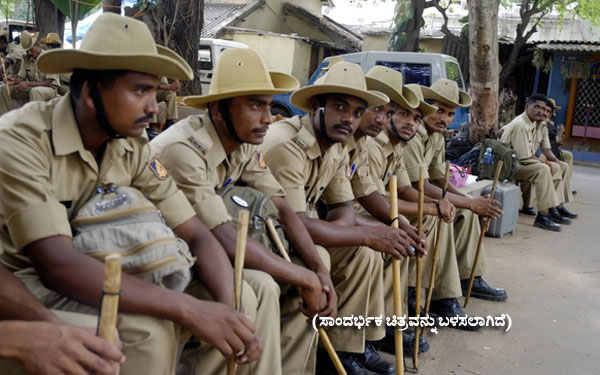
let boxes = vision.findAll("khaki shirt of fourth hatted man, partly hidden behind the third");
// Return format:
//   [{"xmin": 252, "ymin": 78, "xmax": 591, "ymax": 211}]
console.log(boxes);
[{"xmin": 346, "ymin": 136, "xmax": 377, "ymax": 198}]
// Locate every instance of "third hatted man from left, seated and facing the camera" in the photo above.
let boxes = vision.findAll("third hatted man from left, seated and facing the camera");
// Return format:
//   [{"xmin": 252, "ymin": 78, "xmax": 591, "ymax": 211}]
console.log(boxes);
[{"xmin": 261, "ymin": 62, "xmax": 410, "ymax": 375}]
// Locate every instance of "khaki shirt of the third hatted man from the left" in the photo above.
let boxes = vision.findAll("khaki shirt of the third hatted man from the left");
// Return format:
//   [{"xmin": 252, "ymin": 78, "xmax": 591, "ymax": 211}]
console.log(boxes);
[{"xmin": 260, "ymin": 115, "xmax": 354, "ymax": 213}]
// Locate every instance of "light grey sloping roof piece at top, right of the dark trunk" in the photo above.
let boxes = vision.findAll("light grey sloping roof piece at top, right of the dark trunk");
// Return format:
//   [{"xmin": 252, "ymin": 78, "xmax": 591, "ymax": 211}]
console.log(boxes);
[{"xmin": 201, "ymin": 0, "xmax": 264, "ymax": 38}]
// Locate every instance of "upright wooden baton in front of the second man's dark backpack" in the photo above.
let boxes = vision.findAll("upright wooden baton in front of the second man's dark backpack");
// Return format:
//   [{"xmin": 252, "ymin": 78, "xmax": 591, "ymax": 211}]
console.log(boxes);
[{"xmin": 227, "ymin": 210, "xmax": 248, "ymax": 375}]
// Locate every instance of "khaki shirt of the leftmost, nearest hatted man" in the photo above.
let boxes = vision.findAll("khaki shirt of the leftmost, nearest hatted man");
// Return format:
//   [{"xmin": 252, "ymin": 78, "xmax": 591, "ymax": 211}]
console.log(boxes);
[{"xmin": 0, "ymin": 97, "xmax": 194, "ymax": 269}]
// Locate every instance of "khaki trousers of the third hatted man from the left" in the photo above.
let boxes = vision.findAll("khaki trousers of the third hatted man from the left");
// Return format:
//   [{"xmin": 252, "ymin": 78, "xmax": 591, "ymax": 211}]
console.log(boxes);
[{"xmin": 327, "ymin": 246, "xmax": 385, "ymax": 353}]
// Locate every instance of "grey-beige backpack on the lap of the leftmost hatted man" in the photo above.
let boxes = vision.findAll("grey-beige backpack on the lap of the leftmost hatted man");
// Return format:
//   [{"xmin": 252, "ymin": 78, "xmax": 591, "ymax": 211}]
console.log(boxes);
[{"xmin": 71, "ymin": 184, "xmax": 195, "ymax": 292}]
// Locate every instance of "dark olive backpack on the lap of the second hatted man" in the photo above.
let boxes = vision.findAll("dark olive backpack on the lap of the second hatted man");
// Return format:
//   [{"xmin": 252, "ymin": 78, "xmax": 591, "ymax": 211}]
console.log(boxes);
[{"xmin": 217, "ymin": 184, "xmax": 291, "ymax": 256}]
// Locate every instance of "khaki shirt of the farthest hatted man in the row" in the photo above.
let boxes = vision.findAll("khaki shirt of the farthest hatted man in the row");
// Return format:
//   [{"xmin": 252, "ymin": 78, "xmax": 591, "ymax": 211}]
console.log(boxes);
[{"xmin": 404, "ymin": 124, "xmax": 446, "ymax": 182}]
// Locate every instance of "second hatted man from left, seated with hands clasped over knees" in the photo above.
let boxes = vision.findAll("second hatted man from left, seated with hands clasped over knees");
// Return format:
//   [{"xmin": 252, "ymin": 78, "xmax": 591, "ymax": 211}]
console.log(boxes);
[{"xmin": 151, "ymin": 48, "xmax": 337, "ymax": 375}]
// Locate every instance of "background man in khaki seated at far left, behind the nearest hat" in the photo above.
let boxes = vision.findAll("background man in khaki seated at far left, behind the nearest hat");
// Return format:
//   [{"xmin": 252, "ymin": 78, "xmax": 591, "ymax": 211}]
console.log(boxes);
[{"xmin": 0, "ymin": 31, "xmax": 60, "ymax": 115}]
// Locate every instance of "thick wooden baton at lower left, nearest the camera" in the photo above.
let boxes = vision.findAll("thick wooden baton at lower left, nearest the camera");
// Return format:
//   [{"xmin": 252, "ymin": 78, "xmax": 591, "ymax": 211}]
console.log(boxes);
[{"xmin": 98, "ymin": 254, "xmax": 123, "ymax": 344}]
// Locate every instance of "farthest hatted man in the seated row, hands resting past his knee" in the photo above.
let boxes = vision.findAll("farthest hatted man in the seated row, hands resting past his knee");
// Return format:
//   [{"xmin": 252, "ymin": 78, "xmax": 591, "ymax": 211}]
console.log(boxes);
[{"xmin": 404, "ymin": 78, "xmax": 507, "ymax": 316}]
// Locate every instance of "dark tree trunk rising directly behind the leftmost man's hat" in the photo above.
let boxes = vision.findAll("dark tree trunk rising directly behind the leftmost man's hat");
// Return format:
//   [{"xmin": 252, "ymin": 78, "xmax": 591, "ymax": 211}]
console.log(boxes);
[{"xmin": 125, "ymin": 0, "xmax": 204, "ymax": 95}]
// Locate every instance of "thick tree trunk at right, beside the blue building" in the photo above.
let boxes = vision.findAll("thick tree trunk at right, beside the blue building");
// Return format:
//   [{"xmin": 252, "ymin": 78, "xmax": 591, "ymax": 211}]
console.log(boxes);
[{"xmin": 467, "ymin": 0, "xmax": 500, "ymax": 143}]
